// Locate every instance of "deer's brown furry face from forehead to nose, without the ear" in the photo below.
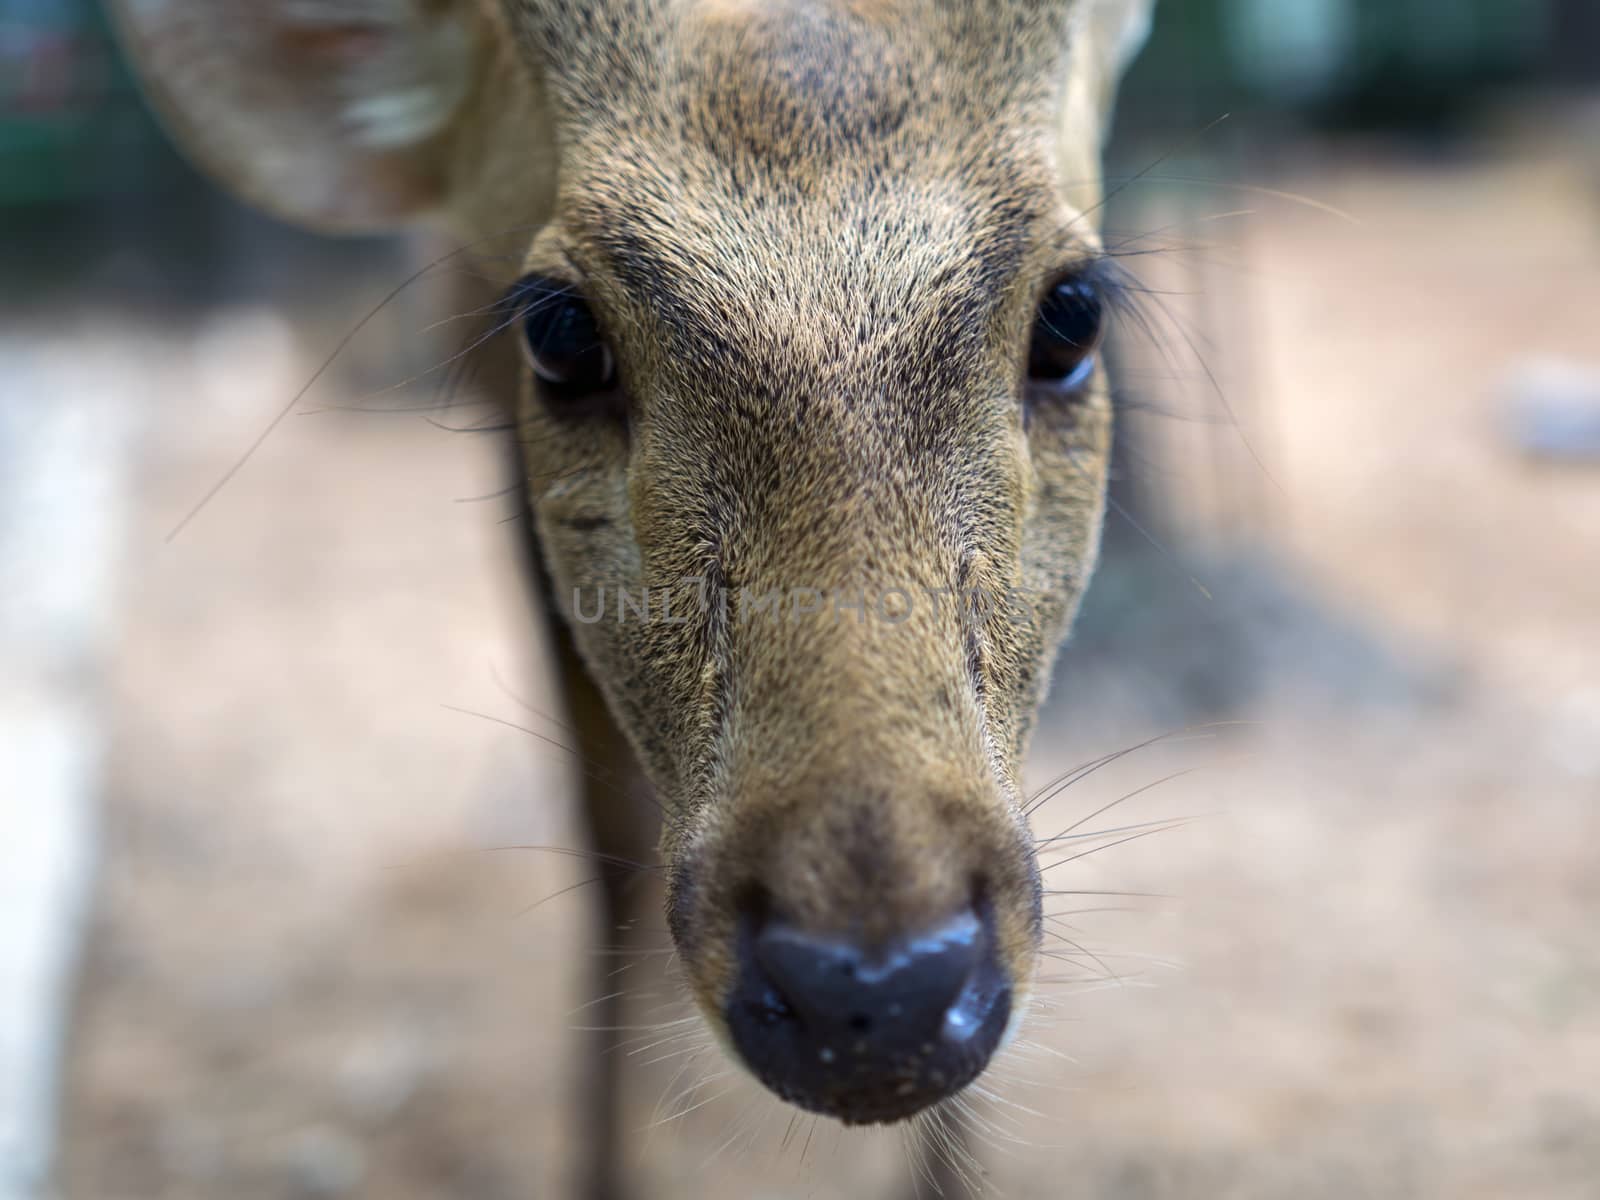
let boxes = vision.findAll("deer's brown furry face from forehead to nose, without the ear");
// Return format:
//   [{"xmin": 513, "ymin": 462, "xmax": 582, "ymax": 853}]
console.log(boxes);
[{"xmin": 520, "ymin": 5, "xmax": 1139, "ymax": 1122}]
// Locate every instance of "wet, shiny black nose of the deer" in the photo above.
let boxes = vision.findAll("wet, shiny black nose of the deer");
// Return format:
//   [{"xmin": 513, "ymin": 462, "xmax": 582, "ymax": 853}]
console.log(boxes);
[{"xmin": 726, "ymin": 906, "xmax": 1011, "ymax": 1125}]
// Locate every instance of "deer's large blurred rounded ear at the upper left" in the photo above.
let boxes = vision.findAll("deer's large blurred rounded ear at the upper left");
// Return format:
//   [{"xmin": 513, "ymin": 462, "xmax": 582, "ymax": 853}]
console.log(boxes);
[{"xmin": 110, "ymin": 0, "xmax": 488, "ymax": 230}]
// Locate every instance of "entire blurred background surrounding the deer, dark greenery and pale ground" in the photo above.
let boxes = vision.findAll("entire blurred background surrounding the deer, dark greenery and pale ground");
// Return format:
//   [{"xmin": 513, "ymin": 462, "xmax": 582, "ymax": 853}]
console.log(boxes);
[{"xmin": 0, "ymin": 0, "xmax": 1600, "ymax": 1200}]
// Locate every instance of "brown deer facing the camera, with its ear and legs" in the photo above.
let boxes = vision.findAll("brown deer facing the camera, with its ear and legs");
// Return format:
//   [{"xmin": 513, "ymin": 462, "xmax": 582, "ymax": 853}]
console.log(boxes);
[{"xmin": 112, "ymin": 0, "xmax": 1154, "ymax": 1200}]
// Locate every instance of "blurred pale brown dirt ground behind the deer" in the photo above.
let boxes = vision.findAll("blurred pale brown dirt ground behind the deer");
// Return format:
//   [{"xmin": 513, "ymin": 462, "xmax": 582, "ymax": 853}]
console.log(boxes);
[{"xmin": 53, "ymin": 136, "xmax": 1600, "ymax": 1200}]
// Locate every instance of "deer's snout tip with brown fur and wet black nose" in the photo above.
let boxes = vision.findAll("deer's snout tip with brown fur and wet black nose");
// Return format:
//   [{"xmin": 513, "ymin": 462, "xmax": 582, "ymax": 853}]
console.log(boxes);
[{"xmin": 667, "ymin": 774, "xmax": 1042, "ymax": 1125}]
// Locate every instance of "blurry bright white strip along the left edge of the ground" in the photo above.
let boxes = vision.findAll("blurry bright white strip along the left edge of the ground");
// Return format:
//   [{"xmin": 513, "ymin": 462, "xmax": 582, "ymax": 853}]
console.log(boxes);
[{"xmin": 0, "ymin": 331, "xmax": 149, "ymax": 1200}]
